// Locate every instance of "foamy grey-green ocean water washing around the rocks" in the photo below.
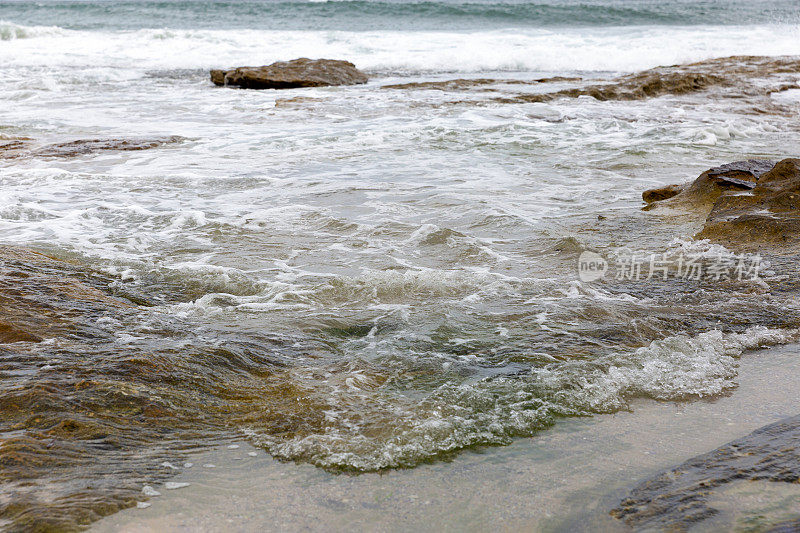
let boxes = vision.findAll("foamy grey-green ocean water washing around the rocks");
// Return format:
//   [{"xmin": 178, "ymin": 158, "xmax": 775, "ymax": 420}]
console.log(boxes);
[{"xmin": 0, "ymin": 0, "xmax": 800, "ymax": 525}]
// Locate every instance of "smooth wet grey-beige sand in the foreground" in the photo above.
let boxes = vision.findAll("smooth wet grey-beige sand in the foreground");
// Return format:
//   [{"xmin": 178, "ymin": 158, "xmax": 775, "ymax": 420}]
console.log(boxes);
[{"xmin": 92, "ymin": 345, "xmax": 800, "ymax": 532}]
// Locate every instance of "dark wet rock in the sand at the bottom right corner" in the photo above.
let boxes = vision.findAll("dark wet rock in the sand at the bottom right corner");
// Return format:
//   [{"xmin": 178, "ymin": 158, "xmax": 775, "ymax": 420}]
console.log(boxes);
[{"xmin": 611, "ymin": 416, "xmax": 800, "ymax": 531}]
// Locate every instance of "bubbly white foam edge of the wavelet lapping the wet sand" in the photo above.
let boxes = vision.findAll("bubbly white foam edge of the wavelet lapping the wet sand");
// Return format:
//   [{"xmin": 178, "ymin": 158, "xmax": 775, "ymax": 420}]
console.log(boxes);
[{"xmin": 247, "ymin": 327, "xmax": 800, "ymax": 470}]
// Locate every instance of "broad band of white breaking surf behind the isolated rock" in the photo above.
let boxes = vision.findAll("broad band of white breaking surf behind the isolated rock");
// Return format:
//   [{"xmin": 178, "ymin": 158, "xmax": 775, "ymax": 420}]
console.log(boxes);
[{"xmin": 0, "ymin": 23, "xmax": 800, "ymax": 72}]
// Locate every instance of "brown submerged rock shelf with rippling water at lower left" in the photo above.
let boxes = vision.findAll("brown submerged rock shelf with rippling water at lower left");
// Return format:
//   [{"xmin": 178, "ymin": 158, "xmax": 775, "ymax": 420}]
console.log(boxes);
[{"xmin": 0, "ymin": 246, "xmax": 318, "ymax": 531}]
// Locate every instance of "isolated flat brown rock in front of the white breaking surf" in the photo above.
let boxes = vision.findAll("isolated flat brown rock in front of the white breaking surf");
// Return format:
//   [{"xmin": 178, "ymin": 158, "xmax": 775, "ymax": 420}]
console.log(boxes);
[{"xmin": 211, "ymin": 57, "xmax": 367, "ymax": 89}]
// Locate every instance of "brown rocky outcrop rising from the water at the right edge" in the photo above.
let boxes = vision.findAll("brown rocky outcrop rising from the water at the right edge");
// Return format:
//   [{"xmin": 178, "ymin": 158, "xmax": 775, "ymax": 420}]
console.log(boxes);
[{"xmin": 642, "ymin": 159, "xmax": 800, "ymax": 251}]
